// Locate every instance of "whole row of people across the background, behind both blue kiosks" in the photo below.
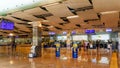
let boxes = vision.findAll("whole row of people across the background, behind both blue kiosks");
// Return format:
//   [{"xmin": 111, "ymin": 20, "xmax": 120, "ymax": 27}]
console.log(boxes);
[{"xmin": 43, "ymin": 40, "xmax": 118, "ymax": 51}]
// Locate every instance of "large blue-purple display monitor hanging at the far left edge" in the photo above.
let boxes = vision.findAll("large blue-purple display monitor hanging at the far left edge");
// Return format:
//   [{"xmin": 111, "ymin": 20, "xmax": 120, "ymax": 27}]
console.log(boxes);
[{"xmin": 0, "ymin": 19, "xmax": 14, "ymax": 30}]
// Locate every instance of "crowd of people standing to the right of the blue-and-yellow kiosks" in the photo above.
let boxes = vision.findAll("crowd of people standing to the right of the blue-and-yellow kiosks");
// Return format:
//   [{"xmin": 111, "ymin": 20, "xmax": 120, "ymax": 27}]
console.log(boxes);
[{"xmin": 74, "ymin": 40, "xmax": 118, "ymax": 51}]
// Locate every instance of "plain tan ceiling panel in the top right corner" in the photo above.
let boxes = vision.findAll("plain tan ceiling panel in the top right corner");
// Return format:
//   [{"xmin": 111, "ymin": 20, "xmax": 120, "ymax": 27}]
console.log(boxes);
[{"xmin": 92, "ymin": 0, "xmax": 120, "ymax": 12}]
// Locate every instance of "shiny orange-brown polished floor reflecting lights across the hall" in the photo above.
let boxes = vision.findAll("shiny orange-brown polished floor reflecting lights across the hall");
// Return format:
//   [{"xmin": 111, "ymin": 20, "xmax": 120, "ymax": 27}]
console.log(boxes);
[{"xmin": 0, "ymin": 46, "xmax": 120, "ymax": 68}]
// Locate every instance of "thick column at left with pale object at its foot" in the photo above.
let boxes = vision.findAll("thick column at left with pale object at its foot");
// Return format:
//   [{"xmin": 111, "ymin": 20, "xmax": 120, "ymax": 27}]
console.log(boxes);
[{"xmin": 29, "ymin": 21, "xmax": 42, "ymax": 57}]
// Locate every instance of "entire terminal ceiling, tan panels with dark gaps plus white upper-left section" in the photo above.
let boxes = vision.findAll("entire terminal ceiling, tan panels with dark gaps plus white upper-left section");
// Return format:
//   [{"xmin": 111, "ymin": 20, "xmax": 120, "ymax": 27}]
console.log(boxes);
[{"xmin": 0, "ymin": 0, "xmax": 120, "ymax": 35}]
